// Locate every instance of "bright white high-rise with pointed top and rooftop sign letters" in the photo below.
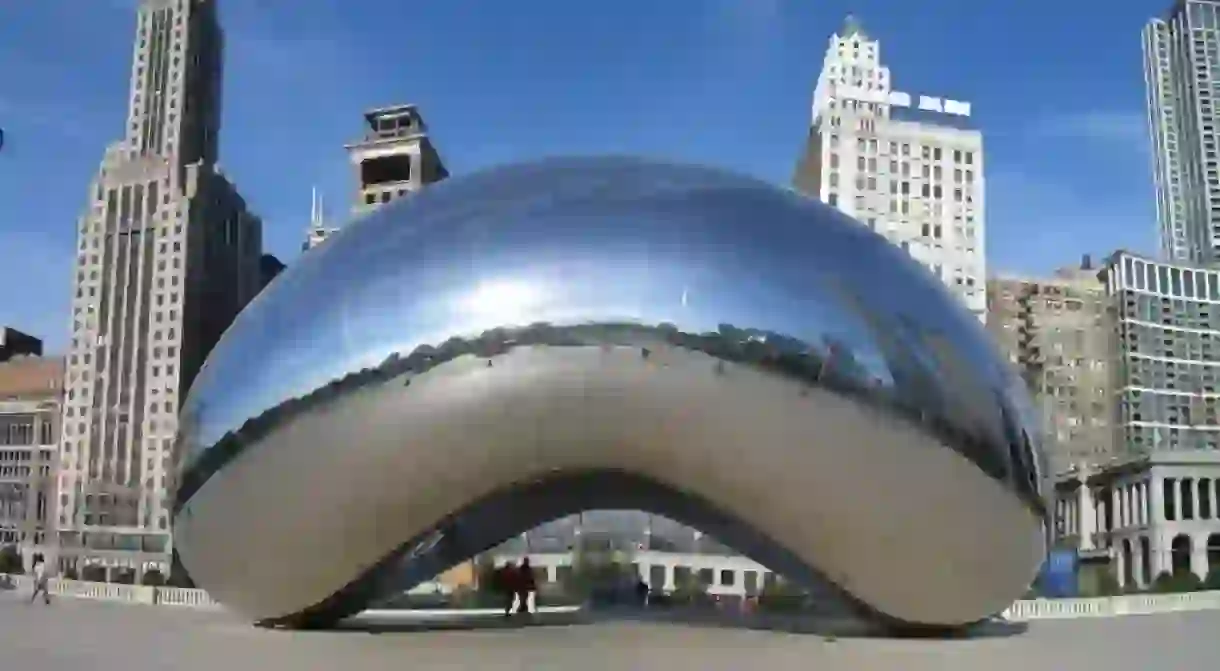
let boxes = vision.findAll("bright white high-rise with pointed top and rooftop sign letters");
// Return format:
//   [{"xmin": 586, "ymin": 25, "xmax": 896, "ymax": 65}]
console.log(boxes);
[{"xmin": 793, "ymin": 17, "xmax": 987, "ymax": 320}]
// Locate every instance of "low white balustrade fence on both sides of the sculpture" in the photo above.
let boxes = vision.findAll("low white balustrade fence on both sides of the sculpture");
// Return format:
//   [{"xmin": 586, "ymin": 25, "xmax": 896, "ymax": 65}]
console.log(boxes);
[{"xmin": 6, "ymin": 576, "xmax": 1220, "ymax": 622}]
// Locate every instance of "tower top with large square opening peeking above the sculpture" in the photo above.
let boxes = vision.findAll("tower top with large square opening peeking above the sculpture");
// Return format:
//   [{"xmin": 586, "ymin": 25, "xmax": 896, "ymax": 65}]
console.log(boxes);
[{"xmin": 346, "ymin": 105, "xmax": 449, "ymax": 216}]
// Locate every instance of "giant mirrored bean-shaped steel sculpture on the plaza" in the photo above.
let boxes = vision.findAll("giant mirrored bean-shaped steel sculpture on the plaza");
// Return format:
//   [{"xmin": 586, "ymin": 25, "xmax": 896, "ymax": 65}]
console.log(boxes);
[{"xmin": 173, "ymin": 157, "xmax": 1046, "ymax": 631}]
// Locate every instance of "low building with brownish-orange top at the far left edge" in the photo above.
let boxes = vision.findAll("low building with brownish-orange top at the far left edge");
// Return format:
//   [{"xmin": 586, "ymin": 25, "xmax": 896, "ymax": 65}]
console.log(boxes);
[{"xmin": 0, "ymin": 356, "xmax": 63, "ymax": 565}]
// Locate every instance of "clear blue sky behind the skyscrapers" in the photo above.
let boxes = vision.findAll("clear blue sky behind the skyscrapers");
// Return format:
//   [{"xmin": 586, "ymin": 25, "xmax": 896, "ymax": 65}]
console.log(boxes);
[{"xmin": 0, "ymin": 0, "xmax": 1169, "ymax": 349}]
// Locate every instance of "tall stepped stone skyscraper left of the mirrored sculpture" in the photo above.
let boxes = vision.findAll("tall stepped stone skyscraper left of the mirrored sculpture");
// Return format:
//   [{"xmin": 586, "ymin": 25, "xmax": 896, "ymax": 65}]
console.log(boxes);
[{"xmin": 59, "ymin": 0, "xmax": 262, "ymax": 576}]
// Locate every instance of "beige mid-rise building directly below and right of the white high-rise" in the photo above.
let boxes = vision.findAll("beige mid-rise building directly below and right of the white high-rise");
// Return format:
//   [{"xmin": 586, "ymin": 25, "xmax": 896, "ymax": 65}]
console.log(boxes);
[{"xmin": 987, "ymin": 256, "xmax": 1114, "ymax": 473}]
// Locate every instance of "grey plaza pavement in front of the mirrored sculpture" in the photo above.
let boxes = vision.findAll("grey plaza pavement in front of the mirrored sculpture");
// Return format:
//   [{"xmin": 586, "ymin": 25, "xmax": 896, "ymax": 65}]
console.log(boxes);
[{"xmin": 0, "ymin": 592, "xmax": 1220, "ymax": 671}]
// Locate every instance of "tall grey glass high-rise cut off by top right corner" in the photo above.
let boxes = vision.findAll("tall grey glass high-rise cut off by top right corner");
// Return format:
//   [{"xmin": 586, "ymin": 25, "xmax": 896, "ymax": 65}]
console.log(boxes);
[{"xmin": 1143, "ymin": 0, "xmax": 1220, "ymax": 264}]
